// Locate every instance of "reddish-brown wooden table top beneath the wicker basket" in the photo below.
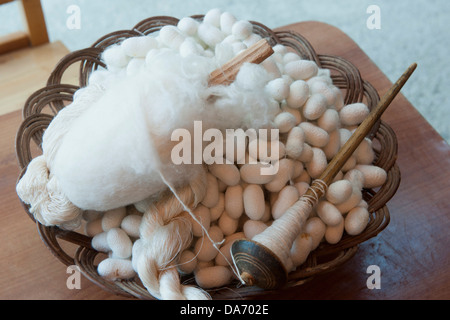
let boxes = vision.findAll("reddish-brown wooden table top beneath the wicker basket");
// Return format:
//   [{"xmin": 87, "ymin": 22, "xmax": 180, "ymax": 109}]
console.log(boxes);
[{"xmin": 0, "ymin": 22, "xmax": 450, "ymax": 300}]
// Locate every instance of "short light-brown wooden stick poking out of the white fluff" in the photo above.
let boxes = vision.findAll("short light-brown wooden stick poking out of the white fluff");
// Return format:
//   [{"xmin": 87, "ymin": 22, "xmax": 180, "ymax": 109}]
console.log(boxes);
[{"xmin": 208, "ymin": 39, "xmax": 273, "ymax": 86}]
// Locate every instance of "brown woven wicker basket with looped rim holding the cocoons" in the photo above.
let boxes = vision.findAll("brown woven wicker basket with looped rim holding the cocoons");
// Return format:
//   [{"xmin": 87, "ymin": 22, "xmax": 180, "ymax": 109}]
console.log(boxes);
[{"xmin": 16, "ymin": 15, "xmax": 400, "ymax": 299}]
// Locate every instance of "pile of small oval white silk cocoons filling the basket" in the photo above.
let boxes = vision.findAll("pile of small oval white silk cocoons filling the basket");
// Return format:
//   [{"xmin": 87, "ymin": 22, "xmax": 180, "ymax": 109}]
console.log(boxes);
[{"xmin": 83, "ymin": 9, "xmax": 387, "ymax": 289}]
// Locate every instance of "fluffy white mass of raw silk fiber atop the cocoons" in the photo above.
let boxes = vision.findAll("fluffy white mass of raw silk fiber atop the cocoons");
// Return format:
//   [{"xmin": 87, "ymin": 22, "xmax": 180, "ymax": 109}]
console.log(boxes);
[{"xmin": 19, "ymin": 48, "xmax": 279, "ymax": 230}]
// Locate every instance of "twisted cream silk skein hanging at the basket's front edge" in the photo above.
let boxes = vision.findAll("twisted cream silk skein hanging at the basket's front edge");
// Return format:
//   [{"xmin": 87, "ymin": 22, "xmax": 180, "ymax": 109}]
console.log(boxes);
[{"xmin": 133, "ymin": 166, "xmax": 209, "ymax": 300}]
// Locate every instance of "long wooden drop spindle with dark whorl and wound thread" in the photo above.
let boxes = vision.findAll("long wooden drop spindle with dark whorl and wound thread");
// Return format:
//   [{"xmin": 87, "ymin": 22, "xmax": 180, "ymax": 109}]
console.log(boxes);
[{"xmin": 231, "ymin": 63, "xmax": 417, "ymax": 289}]
